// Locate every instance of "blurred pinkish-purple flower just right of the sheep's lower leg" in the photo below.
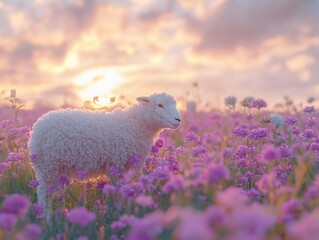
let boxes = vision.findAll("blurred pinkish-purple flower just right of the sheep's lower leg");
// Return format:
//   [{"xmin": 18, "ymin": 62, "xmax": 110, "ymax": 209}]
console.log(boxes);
[{"xmin": 66, "ymin": 207, "xmax": 96, "ymax": 227}]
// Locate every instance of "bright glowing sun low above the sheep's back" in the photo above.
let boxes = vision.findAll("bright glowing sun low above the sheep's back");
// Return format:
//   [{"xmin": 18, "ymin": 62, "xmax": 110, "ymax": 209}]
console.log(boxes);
[{"xmin": 74, "ymin": 68, "xmax": 124, "ymax": 102}]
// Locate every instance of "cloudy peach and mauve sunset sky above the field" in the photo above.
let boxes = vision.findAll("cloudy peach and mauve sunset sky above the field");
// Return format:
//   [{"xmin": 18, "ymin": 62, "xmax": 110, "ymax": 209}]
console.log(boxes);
[{"xmin": 0, "ymin": 0, "xmax": 319, "ymax": 109}]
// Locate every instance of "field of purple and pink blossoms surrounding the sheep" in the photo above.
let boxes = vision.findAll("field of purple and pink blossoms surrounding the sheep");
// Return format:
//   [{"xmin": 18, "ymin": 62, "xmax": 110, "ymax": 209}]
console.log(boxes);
[{"xmin": 0, "ymin": 94, "xmax": 319, "ymax": 240}]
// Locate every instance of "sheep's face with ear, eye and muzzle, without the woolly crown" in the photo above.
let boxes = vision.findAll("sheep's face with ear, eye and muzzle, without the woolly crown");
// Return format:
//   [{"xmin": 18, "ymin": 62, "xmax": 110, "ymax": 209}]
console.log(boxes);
[{"xmin": 137, "ymin": 97, "xmax": 182, "ymax": 129}]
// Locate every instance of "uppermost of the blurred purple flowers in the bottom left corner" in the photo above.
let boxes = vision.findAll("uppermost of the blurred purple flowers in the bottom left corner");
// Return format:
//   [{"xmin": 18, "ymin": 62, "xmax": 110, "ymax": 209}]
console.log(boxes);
[{"xmin": 2, "ymin": 194, "xmax": 30, "ymax": 216}]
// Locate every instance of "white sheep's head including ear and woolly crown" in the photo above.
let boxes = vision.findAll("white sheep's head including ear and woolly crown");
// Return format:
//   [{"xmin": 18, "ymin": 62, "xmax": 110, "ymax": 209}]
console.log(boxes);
[{"xmin": 136, "ymin": 93, "xmax": 182, "ymax": 129}]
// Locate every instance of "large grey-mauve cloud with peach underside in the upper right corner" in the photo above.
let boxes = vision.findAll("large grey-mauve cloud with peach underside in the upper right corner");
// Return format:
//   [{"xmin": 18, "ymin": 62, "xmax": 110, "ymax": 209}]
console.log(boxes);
[{"xmin": 187, "ymin": 0, "xmax": 319, "ymax": 67}]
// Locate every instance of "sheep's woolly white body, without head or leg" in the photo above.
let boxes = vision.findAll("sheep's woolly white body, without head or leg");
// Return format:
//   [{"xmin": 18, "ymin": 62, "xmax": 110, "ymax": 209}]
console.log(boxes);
[{"xmin": 30, "ymin": 104, "xmax": 159, "ymax": 181}]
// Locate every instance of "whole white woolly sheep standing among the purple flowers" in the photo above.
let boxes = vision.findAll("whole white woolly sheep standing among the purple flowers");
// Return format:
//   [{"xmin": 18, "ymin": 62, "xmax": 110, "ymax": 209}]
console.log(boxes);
[{"xmin": 29, "ymin": 93, "xmax": 181, "ymax": 221}]
